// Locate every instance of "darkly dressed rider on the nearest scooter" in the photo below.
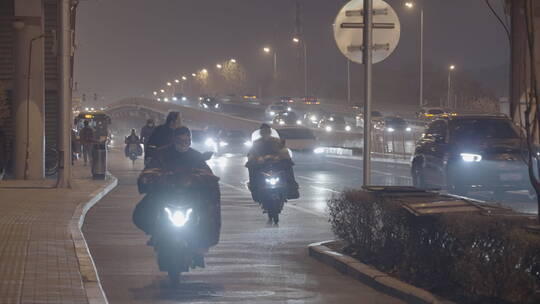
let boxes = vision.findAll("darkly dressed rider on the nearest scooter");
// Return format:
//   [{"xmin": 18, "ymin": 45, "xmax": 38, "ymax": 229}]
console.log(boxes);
[{"xmin": 133, "ymin": 127, "xmax": 221, "ymax": 266}]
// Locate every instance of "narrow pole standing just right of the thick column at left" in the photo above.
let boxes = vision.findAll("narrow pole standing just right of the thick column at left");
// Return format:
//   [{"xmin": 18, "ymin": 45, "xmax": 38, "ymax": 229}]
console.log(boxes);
[{"xmin": 57, "ymin": 0, "xmax": 72, "ymax": 188}]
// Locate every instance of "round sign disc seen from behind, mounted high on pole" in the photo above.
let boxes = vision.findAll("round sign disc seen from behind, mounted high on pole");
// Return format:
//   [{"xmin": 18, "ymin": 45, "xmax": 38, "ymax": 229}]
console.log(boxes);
[{"xmin": 334, "ymin": 0, "xmax": 400, "ymax": 63}]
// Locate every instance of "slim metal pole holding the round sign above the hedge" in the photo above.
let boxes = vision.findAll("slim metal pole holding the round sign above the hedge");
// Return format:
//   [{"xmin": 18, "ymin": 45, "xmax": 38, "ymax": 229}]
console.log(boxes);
[{"xmin": 362, "ymin": 0, "xmax": 373, "ymax": 187}]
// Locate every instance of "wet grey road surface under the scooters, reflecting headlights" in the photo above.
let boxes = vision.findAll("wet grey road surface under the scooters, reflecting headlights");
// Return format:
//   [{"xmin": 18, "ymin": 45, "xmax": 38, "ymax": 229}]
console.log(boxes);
[{"xmin": 83, "ymin": 152, "xmax": 406, "ymax": 303}]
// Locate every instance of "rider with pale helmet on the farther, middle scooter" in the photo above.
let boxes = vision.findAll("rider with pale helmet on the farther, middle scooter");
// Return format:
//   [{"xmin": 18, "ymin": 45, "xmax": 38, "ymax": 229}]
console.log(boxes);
[{"xmin": 246, "ymin": 124, "xmax": 300, "ymax": 201}]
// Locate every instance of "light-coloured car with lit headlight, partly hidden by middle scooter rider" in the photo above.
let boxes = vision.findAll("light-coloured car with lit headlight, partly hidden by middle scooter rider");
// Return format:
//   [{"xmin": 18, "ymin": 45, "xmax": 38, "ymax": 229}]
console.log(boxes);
[{"xmin": 276, "ymin": 127, "xmax": 325, "ymax": 165}]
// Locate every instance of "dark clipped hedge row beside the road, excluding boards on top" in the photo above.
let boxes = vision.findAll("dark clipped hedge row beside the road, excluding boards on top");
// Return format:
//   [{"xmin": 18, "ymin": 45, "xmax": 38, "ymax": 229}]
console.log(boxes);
[{"xmin": 329, "ymin": 190, "xmax": 540, "ymax": 303}]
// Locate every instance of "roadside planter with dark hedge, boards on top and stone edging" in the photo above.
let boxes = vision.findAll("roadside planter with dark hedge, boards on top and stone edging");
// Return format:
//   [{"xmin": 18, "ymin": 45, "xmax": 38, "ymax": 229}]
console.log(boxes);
[{"xmin": 320, "ymin": 187, "xmax": 540, "ymax": 303}]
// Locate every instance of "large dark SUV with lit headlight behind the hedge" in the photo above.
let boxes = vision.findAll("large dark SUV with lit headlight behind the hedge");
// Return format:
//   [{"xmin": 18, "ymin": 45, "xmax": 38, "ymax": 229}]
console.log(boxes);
[{"xmin": 411, "ymin": 115, "xmax": 534, "ymax": 195}]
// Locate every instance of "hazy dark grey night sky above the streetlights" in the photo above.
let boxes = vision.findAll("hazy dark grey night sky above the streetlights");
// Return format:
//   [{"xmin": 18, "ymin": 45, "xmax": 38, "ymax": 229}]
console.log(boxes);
[{"xmin": 75, "ymin": 0, "xmax": 509, "ymax": 102}]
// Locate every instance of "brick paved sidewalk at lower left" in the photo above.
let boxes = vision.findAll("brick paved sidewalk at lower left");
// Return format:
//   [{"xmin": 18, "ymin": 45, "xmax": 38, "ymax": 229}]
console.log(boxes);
[{"xmin": 0, "ymin": 165, "xmax": 116, "ymax": 304}]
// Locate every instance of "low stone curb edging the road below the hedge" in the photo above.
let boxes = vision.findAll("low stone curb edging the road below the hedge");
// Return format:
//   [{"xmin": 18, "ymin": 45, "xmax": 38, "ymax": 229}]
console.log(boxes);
[{"xmin": 308, "ymin": 241, "xmax": 455, "ymax": 304}]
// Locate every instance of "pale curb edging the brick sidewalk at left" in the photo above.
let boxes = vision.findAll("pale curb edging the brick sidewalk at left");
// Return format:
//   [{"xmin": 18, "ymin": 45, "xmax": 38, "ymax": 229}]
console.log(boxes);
[{"xmin": 69, "ymin": 174, "xmax": 118, "ymax": 304}]
